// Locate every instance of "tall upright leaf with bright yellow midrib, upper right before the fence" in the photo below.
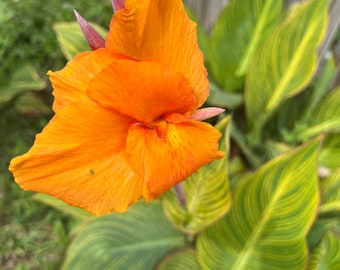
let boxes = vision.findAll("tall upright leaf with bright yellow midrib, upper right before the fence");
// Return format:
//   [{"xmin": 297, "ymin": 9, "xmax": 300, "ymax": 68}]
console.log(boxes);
[{"xmin": 245, "ymin": 0, "xmax": 328, "ymax": 139}]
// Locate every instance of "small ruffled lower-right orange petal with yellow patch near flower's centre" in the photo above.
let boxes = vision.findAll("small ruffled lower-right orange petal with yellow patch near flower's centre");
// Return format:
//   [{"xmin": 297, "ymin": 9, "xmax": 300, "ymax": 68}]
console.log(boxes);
[{"xmin": 126, "ymin": 120, "xmax": 224, "ymax": 200}]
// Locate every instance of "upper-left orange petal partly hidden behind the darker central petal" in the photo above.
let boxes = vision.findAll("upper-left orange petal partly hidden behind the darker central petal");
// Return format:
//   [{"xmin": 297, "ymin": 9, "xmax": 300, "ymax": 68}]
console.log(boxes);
[{"xmin": 48, "ymin": 49, "xmax": 118, "ymax": 112}]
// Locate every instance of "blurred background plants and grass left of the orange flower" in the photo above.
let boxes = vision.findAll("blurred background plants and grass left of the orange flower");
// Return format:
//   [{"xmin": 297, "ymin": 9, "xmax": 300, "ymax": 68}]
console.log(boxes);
[{"xmin": 0, "ymin": 0, "xmax": 112, "ymax": 269}]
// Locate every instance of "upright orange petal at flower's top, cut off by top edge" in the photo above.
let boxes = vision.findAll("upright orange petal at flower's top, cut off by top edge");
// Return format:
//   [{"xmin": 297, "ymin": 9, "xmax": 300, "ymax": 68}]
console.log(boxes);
[{"xmin": 106, "ymin": 0, "xmax": 208, "ymax": 107}]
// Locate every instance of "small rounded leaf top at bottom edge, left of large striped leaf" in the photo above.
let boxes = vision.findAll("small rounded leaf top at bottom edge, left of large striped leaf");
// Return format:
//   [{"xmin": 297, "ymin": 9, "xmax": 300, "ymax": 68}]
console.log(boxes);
[{"xmin": 156, "ymin": 249, "xmax": 201, "ymax": 270}]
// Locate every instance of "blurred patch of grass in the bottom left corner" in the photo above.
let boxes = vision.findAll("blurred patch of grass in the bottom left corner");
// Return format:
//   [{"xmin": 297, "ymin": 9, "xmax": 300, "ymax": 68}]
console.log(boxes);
[{"xmin": 0, "ymin": 185, "xmax": 69, "ymax": 269}]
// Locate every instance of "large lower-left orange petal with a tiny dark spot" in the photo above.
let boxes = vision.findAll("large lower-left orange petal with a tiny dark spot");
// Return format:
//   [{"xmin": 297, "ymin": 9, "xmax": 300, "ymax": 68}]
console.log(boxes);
[{"xmin": 10, "ymin": 100, "xmax": 143, "ymax": 215}]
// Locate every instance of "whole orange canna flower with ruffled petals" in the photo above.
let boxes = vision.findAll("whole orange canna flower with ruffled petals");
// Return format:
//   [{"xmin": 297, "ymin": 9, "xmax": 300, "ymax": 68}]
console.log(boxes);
[{"xmin": 9, "ymin": 0, "xmax": 224, "ymax": 215}]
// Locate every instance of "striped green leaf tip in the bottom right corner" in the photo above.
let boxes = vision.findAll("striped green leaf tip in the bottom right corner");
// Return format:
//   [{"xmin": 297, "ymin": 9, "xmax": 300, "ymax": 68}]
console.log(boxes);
[{"xmin": 308, "ymin": 231, "xmax": 340, "ymax": 270}]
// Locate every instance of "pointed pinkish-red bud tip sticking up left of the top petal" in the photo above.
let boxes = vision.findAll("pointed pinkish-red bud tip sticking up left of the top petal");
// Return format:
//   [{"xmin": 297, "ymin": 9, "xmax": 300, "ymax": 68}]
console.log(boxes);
[{"xmin": 74, "ymin": 10, "xmax": 105, "ymax": 50}]
